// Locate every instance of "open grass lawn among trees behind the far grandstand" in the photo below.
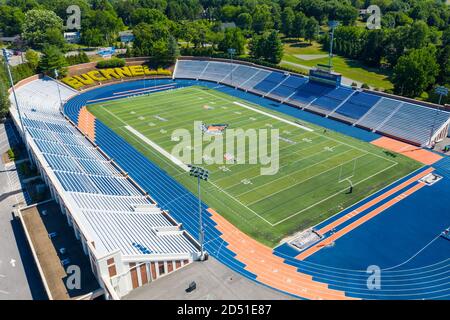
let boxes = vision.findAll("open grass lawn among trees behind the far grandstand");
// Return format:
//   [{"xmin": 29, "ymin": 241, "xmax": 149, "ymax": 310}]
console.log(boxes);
[{"xmin": 281, "ymin": 42, "xmax": 393, "ymax": 90}]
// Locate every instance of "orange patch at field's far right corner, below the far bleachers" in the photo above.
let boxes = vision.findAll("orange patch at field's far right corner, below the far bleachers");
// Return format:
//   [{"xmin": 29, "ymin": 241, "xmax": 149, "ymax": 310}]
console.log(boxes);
[{"xmin": 372, "ymin": 137, "xmax": 442, "ymax": 166}]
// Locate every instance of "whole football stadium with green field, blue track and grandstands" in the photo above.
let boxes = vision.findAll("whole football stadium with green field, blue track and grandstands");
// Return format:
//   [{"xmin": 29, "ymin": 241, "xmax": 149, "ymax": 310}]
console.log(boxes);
[{"xmin": 4, "ymin": 57, "xmax": 450, "ymax": 299}]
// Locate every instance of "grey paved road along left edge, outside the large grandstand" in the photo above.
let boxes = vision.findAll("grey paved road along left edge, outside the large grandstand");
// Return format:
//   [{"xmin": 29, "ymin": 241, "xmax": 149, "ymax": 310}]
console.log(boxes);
[{"xmin": 0, "ymin": 120, "xmax": 46, "ymax": 300}]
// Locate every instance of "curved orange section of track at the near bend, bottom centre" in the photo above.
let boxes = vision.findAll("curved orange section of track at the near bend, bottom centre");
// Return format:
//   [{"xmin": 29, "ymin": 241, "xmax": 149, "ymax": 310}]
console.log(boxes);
[{"xmin": 208, "ymin": 208, "xmax": 353, "ymax": 300}]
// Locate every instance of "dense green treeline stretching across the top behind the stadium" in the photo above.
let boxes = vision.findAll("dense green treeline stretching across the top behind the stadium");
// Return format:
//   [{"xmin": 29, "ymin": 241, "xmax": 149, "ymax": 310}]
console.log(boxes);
[{"xmin": 0, "ymin": 0, "xmax": 450, "ymax": 101}]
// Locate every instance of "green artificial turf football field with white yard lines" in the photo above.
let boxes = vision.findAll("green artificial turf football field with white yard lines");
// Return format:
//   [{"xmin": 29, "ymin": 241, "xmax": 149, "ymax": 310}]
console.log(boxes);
[{"xmin": 89, "ymin": 86, "xmax": 421, "ymax": 246}]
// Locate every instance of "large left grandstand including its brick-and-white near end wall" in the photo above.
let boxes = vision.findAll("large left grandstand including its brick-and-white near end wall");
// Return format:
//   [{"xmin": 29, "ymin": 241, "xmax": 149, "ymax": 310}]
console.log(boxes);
[{"xmin": 8, "ymin": 77, "xmax": 199, "ymax": 298}]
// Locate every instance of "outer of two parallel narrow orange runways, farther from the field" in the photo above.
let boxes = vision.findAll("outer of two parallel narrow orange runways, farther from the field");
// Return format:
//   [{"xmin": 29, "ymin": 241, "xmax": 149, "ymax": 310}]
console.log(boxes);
[{"xmin": 296, "ymin": 182, "xmax": 425, "ymax": 260}]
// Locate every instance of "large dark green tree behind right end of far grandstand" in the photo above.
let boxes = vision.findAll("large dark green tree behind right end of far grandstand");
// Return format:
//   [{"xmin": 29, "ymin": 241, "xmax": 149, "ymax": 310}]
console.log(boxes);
[{"xmin": 392, "ymin": 46, "xmax": 439, "ymax": 98}]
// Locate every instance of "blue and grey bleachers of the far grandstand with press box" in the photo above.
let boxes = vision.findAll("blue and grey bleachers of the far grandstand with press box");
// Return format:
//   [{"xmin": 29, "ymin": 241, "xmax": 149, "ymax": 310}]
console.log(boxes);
[{"xmin": 174, "ymin": 60, "xmax": 450, "ymax": 146}]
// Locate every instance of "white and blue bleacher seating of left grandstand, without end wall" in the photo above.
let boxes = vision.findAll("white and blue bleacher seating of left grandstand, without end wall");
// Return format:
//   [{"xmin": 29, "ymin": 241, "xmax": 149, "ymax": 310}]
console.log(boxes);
[{"xmin": 8, "ymin": 78, "xmax": 198, "ymax": 256}]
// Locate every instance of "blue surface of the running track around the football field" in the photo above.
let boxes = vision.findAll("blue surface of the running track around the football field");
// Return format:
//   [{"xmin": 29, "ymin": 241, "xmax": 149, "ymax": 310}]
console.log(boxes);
[{"xmin": 65, "ymin": 80, "xmax": 450, "ymax": 299}]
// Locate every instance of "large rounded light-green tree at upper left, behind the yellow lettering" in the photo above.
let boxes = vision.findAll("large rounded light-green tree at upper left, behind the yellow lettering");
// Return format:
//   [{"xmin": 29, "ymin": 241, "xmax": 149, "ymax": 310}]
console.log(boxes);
[{"xmin": 22, "ymin": 9, "xmax": 64, "ymax": 48}]
